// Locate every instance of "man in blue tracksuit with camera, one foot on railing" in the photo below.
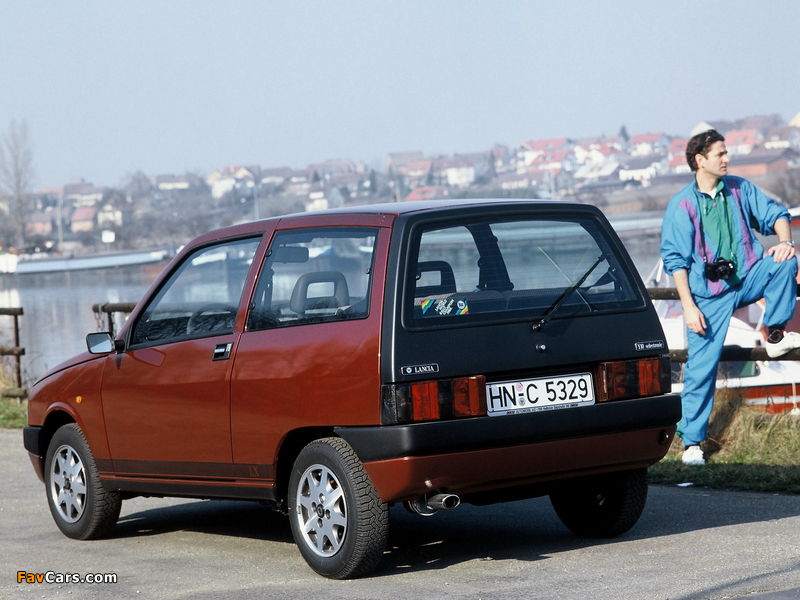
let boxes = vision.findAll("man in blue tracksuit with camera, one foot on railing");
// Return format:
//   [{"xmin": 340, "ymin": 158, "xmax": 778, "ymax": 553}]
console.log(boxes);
[{"xmin": 661, "ymin": 129, "xmax": 800, "ymax": 464}]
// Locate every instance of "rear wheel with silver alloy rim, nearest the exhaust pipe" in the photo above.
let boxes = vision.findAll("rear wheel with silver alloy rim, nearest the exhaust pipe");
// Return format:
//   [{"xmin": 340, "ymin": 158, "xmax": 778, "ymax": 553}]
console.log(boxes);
[{"xmin": 288, "ymin": 437, "xmax": 389, "ymax": 579}]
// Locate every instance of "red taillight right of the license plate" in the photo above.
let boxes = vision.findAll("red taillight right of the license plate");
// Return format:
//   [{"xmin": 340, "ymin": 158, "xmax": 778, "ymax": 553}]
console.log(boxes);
[{"xmin": 597, "ymin": 356, "xmax": 672, "ymax": 402}]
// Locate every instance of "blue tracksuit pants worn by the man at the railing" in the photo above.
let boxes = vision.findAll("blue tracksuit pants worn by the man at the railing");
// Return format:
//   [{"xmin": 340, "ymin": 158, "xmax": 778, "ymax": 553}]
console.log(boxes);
[{"xmin": 678, "ymin": 255, "xmax": 797, "ymax": 446}]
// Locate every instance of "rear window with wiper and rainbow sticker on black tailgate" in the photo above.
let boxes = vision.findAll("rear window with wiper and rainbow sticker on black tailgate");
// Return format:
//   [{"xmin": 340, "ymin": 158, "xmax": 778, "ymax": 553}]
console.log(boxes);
[{"xmin": 405, "ymin": 215, "xmax": 644, "ymax": 327}]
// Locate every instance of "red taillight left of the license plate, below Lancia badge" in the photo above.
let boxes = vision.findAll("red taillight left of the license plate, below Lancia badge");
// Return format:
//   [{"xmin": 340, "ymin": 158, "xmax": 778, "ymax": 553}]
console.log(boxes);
[{"xmin": 381, "ymin": 375, "xmax": 486, "ymax": 425}]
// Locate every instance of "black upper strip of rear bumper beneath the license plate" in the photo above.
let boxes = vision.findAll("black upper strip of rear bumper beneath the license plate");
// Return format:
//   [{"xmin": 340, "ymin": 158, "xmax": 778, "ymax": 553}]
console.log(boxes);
[{"xmin": 335, "ymin": 394, "xmax": 681, "ymax": 462}]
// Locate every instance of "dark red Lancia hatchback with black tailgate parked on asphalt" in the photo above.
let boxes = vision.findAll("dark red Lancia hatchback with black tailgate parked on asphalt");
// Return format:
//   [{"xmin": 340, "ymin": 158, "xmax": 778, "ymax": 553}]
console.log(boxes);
[{"xmin": 24, "ymin": 200, "xmax": 680, "ymax": 578}]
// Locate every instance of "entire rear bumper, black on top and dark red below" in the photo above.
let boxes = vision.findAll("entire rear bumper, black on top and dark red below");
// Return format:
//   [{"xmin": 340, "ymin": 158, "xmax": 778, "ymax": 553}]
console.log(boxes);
[{"xmin": 336, "ymin": 394, "xmax": 681, "ymax": 502}]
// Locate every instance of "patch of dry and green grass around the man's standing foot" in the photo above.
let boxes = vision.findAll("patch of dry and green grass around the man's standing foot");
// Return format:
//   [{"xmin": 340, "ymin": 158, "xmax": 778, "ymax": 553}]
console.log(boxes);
[{"xmin": 649, "ymin": 390, "xmax": 800, "ymax": 494}]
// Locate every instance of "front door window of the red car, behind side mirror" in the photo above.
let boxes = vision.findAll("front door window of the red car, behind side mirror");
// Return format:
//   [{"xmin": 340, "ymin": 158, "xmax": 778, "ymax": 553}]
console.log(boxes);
[{"xmin": 131, "ymin": 238, "xmax": 260, "ymax": 344}]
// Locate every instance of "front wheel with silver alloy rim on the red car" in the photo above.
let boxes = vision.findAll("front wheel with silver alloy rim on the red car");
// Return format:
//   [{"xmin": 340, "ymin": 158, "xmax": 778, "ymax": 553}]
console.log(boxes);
[{"xmin": 44, "ymin": 423, "xmax": 122, "ymax": 540}]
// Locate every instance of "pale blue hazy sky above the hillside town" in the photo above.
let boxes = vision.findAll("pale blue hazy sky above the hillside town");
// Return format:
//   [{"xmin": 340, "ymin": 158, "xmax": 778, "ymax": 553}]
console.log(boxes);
[{"xmin": 0, "ymin": 0, "xmax": 800, "ymax": 188}]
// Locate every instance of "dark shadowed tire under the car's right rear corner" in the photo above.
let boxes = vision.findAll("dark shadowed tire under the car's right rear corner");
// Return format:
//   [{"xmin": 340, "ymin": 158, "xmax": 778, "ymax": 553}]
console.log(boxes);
[{"xmin": 550, "ymin": 469, "xmax": 647, "ymax": 538}]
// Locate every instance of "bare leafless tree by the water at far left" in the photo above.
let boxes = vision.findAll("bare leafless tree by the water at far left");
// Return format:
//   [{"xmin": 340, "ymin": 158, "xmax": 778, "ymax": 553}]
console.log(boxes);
[{"xmin": 0, "ymin": 119, "xmax": 33, "ymax": 245}]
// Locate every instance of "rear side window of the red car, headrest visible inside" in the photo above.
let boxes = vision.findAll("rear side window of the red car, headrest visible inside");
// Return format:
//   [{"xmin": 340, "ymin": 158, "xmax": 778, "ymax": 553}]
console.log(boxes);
[{"xmin": 247, "ymin": 227, "xmax": 378, "ymax": 331}]
